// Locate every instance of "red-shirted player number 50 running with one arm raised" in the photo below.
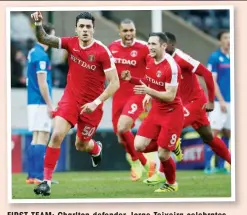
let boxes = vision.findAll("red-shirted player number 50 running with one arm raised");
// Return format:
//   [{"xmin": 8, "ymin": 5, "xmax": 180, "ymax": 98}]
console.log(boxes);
[{"xmin": 31, "ymin": 12, "xmax": 119, "ymax": 196}]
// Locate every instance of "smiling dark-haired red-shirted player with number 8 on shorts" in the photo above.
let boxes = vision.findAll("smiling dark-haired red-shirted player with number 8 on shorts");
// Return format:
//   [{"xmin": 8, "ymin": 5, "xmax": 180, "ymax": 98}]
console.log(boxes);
[{"xmin": 121, "ymin": 33, "xmax": 184, "ymax": 192}]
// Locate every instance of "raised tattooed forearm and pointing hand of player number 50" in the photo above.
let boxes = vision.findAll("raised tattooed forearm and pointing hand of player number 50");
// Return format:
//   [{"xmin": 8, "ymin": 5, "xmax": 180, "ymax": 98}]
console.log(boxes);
[{"xmin": 31, "ymin": 11, "xmax": 60, "ymax": 48}]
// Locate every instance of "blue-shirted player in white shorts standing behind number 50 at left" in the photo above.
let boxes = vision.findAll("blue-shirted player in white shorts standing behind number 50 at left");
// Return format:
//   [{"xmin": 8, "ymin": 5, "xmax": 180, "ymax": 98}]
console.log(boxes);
[{"xmin": 26, "ymin": 24, "xmax": 55, "ymax": 184}]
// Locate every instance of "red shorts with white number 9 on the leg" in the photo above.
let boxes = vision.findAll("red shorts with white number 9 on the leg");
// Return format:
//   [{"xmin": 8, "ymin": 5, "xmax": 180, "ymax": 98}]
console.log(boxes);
[{"xmin": 112, "ymin": 95, "xmax": 144, "ymax": 133}]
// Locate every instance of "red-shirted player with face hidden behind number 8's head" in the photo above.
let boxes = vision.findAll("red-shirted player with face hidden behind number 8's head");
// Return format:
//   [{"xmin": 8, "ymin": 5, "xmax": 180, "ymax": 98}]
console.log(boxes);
[{"xmin": 144, "ymin": 32, "xmax": 231, "ymax": 184}]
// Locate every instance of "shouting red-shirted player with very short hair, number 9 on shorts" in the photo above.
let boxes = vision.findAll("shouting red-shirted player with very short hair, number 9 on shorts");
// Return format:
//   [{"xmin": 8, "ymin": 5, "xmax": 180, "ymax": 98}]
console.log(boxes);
[{"xmin": 109, "ymin": 19, "xmax": 155, "ymax": 181}]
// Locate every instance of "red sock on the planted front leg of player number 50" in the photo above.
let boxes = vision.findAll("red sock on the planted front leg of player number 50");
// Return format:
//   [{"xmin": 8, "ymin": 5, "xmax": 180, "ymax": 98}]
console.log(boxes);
[{"xmin": 44, "ymin": 146, "xmax": 60, "ymax": 181}]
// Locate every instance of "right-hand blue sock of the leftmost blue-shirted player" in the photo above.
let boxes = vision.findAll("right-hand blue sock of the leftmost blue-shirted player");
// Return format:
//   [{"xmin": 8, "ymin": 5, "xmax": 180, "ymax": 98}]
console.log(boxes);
[{"xmin": 34, "ymin": 144, "xmax": 46, "ymax": 180}]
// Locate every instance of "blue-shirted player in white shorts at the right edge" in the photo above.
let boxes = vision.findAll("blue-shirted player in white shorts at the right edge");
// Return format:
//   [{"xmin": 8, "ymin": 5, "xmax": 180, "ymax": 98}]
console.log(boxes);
[{"xmin": 205, "ymin": 31, "xmax": 231, "ymax": 173}]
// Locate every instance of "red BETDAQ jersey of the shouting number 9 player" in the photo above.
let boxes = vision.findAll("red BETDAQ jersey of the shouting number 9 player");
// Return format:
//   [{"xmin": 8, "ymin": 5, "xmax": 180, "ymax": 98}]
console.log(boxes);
[{"xmin": 109, "ymin": 39, "xmax": 149, "ymax": 98}]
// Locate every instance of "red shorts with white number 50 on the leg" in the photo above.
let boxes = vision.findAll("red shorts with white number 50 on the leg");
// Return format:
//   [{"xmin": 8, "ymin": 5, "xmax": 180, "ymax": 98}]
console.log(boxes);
[{"xmin": 54, "ymin": 88, "xmax": 103, "ymax": 142}]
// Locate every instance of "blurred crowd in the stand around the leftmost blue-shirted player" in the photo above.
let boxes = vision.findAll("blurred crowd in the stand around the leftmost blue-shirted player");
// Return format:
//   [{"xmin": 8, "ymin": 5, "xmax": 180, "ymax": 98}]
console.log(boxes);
[{"xmin": 10, "ymin": 11, "xmax": 68, "ymax": 88}]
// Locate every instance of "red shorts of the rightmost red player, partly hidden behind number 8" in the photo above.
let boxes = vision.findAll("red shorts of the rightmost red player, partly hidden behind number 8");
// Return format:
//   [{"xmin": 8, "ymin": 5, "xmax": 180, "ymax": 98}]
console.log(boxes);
[{"xmin": 184, "ymin": 98, "xmax": 210, "ymax": 130}]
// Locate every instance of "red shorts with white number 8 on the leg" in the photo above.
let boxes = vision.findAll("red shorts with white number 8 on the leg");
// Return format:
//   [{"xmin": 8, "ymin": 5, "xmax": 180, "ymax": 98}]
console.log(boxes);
[{"xmin": 137, "ymin": 106, "xmax": 184, "ymax": 151}]
